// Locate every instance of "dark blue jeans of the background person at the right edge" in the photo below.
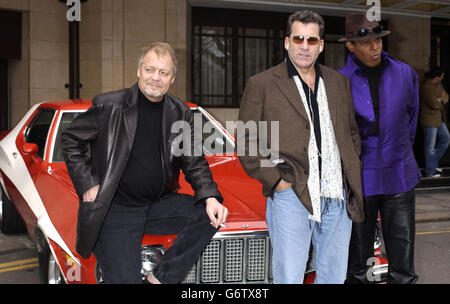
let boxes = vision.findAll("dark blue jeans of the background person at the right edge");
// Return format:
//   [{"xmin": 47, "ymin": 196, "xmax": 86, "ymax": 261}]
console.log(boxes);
[{"xmin": 423, "ymin": 122, "xmax": 450, "ymax": 175}]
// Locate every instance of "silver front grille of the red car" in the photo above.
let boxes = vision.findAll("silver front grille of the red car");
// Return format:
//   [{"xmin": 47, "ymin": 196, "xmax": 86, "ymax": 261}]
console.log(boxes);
[{"xmin": 183, "ymin": 231, "xmax": 313, "ymax": 283}]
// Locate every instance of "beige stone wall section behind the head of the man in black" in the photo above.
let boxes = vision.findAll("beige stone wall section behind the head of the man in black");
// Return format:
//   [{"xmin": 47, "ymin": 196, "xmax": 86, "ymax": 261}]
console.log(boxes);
[{"xmin": 80, "ymin": 0, "xmax": 188, "ymax": 100}]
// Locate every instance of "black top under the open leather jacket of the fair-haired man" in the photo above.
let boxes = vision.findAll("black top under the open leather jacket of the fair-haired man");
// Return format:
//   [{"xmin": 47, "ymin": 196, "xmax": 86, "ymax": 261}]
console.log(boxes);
[{"xmin": 113, "ymin": 90, "xmax": 164, "ymax": 205}]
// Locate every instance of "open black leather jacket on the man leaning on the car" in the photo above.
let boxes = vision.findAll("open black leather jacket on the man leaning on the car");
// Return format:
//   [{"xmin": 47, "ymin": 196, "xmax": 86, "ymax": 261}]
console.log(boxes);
[{"xmin": 61, "ymin": 83, "xmax": 223, "ymax": 258}]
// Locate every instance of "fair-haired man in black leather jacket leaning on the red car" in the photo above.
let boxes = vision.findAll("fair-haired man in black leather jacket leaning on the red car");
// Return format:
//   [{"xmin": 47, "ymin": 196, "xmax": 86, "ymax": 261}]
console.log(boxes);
[{"xmin": 61, "ymin": 42, "xmax": 228, "ymax": 283}]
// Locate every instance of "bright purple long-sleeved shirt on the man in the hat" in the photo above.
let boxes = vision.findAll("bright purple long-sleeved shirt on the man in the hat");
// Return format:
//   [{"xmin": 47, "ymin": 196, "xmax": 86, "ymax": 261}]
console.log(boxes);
[{"xmin": 340, "ymin": 52, "xmax": 421, "ymax": 196}]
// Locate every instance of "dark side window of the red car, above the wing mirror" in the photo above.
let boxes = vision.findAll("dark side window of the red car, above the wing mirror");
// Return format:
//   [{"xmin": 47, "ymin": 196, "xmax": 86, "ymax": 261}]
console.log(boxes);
[{"xmin": 25, "ymin": 108, "xmax": 55, "ymax": 158}]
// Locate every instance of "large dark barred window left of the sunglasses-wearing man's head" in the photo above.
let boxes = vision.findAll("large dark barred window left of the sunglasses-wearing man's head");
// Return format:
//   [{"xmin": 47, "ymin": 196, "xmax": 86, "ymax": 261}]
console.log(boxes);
[{"xmin": 192, "ymin": 8, "xmax": 288, "ymax": 107}]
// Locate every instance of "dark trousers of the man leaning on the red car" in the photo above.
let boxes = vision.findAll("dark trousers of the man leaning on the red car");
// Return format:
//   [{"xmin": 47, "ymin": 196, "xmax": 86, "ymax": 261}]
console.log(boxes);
[{"xmin": 93, "ymin": 194, "xmax": 217, "ymax": 284}]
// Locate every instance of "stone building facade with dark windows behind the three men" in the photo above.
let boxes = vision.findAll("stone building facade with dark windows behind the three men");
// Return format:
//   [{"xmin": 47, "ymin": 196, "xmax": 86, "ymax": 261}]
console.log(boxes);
[{"xmin": 0, "ymin": 0, "xmax": 450, "ymax": 129}]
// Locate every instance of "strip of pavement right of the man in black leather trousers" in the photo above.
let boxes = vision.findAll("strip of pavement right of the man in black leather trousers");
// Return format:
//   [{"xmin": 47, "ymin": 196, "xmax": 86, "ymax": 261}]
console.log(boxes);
[{"xmin": 416, "ymin": 189, "xmax": 450, "ymax": 223}]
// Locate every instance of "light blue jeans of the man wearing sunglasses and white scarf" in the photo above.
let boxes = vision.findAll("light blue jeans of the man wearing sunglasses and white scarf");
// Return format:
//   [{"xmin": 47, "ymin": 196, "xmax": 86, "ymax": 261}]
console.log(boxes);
[{"xmin": 266, "ymin": 188, "xmax": 352, "ymax": 284}]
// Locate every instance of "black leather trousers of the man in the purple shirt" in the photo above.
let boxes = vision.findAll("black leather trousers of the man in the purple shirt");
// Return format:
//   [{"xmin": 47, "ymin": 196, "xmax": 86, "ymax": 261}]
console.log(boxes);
[{"xmin": 346, "ymin": 189, "xmax": 418, "ymax": 284}]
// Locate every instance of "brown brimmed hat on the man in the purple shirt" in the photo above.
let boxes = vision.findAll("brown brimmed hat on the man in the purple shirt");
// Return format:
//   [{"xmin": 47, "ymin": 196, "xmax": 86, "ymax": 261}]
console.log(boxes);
[{"xmin": 338, "ymin": 14, "xmax": 391, "ymax": 42}]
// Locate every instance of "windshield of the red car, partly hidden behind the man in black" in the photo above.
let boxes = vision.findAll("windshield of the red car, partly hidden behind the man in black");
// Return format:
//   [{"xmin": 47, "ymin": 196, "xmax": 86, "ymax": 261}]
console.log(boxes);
[{"xmin": 52, "ymin": 108, "xmax": 234, "ymax": 162}]
